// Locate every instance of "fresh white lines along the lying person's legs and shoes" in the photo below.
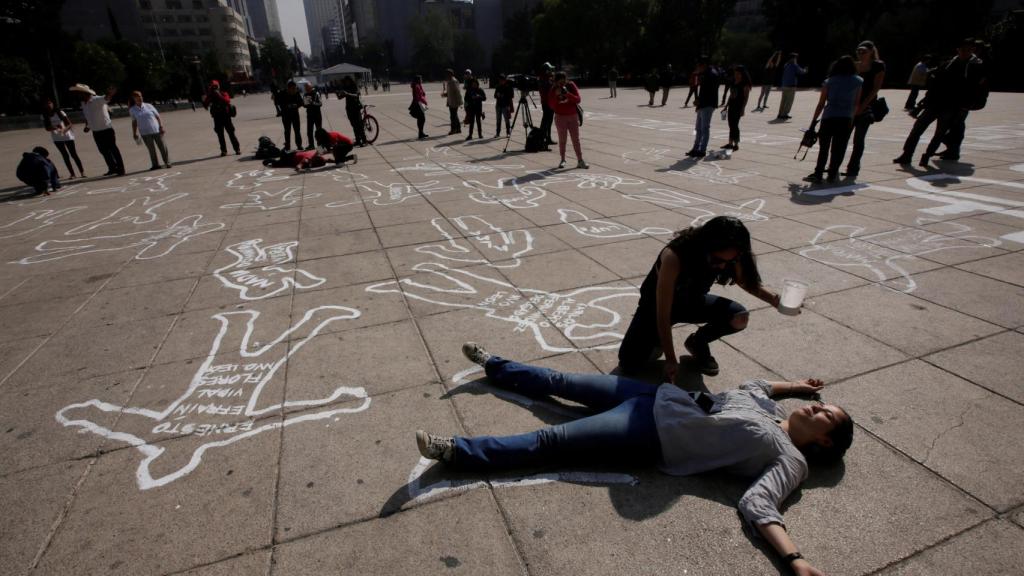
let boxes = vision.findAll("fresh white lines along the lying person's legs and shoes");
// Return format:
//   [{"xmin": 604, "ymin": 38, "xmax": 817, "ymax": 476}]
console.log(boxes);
[{"xmin": 407, "ymin": 366, "xmax": 640, "ymax": 504}]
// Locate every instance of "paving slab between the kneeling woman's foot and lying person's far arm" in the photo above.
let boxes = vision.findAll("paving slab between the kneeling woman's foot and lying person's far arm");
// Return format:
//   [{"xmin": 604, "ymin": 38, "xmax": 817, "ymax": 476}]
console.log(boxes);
[{"xmin": 729, "ymin": 308, "xmax": 906, "ymax": 382}]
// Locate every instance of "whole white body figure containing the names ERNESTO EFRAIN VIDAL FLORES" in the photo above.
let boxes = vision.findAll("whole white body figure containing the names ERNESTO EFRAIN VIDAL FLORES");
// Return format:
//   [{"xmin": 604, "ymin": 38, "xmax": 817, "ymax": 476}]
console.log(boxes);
[{"xmin": 55, "ymin": 306, "xmax": 371, "ymax": 490}]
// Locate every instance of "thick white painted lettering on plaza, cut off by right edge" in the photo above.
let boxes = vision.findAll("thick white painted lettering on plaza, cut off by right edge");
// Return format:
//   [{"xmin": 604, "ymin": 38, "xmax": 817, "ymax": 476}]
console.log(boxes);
[{"xmin": 801, "ymin": 172, "xmax": 1024, "ymax": 244}]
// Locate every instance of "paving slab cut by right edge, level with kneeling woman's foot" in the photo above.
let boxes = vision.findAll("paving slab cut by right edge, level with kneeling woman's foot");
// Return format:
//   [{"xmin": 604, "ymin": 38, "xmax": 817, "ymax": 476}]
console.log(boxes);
[{"xmin": 925, "ymin": 332, "xmax": 1024, "ymax": 403}]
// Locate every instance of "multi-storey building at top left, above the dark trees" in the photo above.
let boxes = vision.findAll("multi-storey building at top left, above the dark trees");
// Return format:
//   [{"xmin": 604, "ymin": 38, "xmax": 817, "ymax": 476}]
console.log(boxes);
[{"xmin": 60, "ymin": 0, "xmax": 253, "ymax": 77}]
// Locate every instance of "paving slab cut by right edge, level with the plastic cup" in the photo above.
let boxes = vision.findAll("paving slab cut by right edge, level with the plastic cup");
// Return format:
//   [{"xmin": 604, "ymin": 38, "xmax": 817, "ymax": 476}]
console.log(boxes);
[{"xmin": 914, "ymin": 269, "xmax": 1024, "ymax": 328}]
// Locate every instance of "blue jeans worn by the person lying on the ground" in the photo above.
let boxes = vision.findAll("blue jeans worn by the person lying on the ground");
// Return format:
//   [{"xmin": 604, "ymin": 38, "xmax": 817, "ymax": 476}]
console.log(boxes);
[{"xmin": 452, "ymin": 357, "xmax": 662, "ymax": 470}]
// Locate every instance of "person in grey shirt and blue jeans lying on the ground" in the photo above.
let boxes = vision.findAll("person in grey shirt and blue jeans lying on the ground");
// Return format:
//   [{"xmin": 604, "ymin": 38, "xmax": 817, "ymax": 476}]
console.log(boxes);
[{"xmin": 416, "ymin": 342, "xmax": 853, "ymax": 575}]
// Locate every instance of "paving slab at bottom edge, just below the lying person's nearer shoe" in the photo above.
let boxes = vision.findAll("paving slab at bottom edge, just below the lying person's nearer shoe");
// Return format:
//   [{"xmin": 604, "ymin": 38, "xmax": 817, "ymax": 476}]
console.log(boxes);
[{"xmin": 272, "ymin": 490, "xmax": 523, "ymax": 576}]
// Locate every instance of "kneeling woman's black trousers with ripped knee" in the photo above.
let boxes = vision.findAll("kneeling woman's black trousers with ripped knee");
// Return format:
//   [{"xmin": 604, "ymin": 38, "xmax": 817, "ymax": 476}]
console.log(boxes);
[{"xmin": 618, "ymin": 293, "xmax": 746, "ymax": 371}]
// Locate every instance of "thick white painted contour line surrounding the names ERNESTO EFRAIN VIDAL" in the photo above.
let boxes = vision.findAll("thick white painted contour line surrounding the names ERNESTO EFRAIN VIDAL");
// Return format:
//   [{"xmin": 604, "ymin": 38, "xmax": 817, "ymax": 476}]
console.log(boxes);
[{"xmin": 54, "ymin": 305, "xmax": 371, "ymax": 490}]
